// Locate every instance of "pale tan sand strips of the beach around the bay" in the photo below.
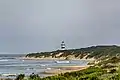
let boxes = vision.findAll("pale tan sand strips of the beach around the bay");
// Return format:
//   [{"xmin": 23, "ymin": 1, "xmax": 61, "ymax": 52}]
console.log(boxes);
[{"xmin": 20, "ymin": 57, "xmax": 95, "ymax": 75}]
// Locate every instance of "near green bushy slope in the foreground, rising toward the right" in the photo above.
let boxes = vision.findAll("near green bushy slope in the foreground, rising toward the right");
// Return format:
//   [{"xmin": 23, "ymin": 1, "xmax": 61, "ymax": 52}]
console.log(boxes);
[{"xmin": 16, "ymin": 56, "xmax": 120, "ymax": 80}]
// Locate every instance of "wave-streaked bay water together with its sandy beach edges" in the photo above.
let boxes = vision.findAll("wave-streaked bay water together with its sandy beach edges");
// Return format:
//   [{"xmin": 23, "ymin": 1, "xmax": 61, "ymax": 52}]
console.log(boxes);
[{"xmin": 0, "ymin": 55, "xmax": 88, "ymax": 78}]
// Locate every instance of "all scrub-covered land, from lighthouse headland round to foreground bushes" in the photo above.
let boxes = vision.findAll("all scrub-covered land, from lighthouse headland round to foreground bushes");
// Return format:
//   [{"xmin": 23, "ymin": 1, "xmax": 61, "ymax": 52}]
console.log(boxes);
[{"xmin": 16, "ymin": 45, "xmax": 120, "ymax": 80}]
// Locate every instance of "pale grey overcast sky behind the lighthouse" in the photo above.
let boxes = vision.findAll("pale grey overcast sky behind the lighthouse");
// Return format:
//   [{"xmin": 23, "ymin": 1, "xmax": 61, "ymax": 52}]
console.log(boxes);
[{"xmin": 0, "ymin": 0, "xmax": 120, "ymax": 53}]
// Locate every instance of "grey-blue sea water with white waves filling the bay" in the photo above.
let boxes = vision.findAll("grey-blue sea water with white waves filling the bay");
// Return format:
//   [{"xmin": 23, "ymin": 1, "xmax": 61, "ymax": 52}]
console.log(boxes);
[{"xmin": 0, "ymin": 54, "xmax": 87, "ymax": 77}]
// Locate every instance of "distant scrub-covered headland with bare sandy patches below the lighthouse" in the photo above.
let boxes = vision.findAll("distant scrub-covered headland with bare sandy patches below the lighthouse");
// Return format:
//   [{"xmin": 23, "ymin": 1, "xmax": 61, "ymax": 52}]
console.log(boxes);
[{"xmin": 26, "ymin": 45, "xmax": 120, "ymax": 59}]
